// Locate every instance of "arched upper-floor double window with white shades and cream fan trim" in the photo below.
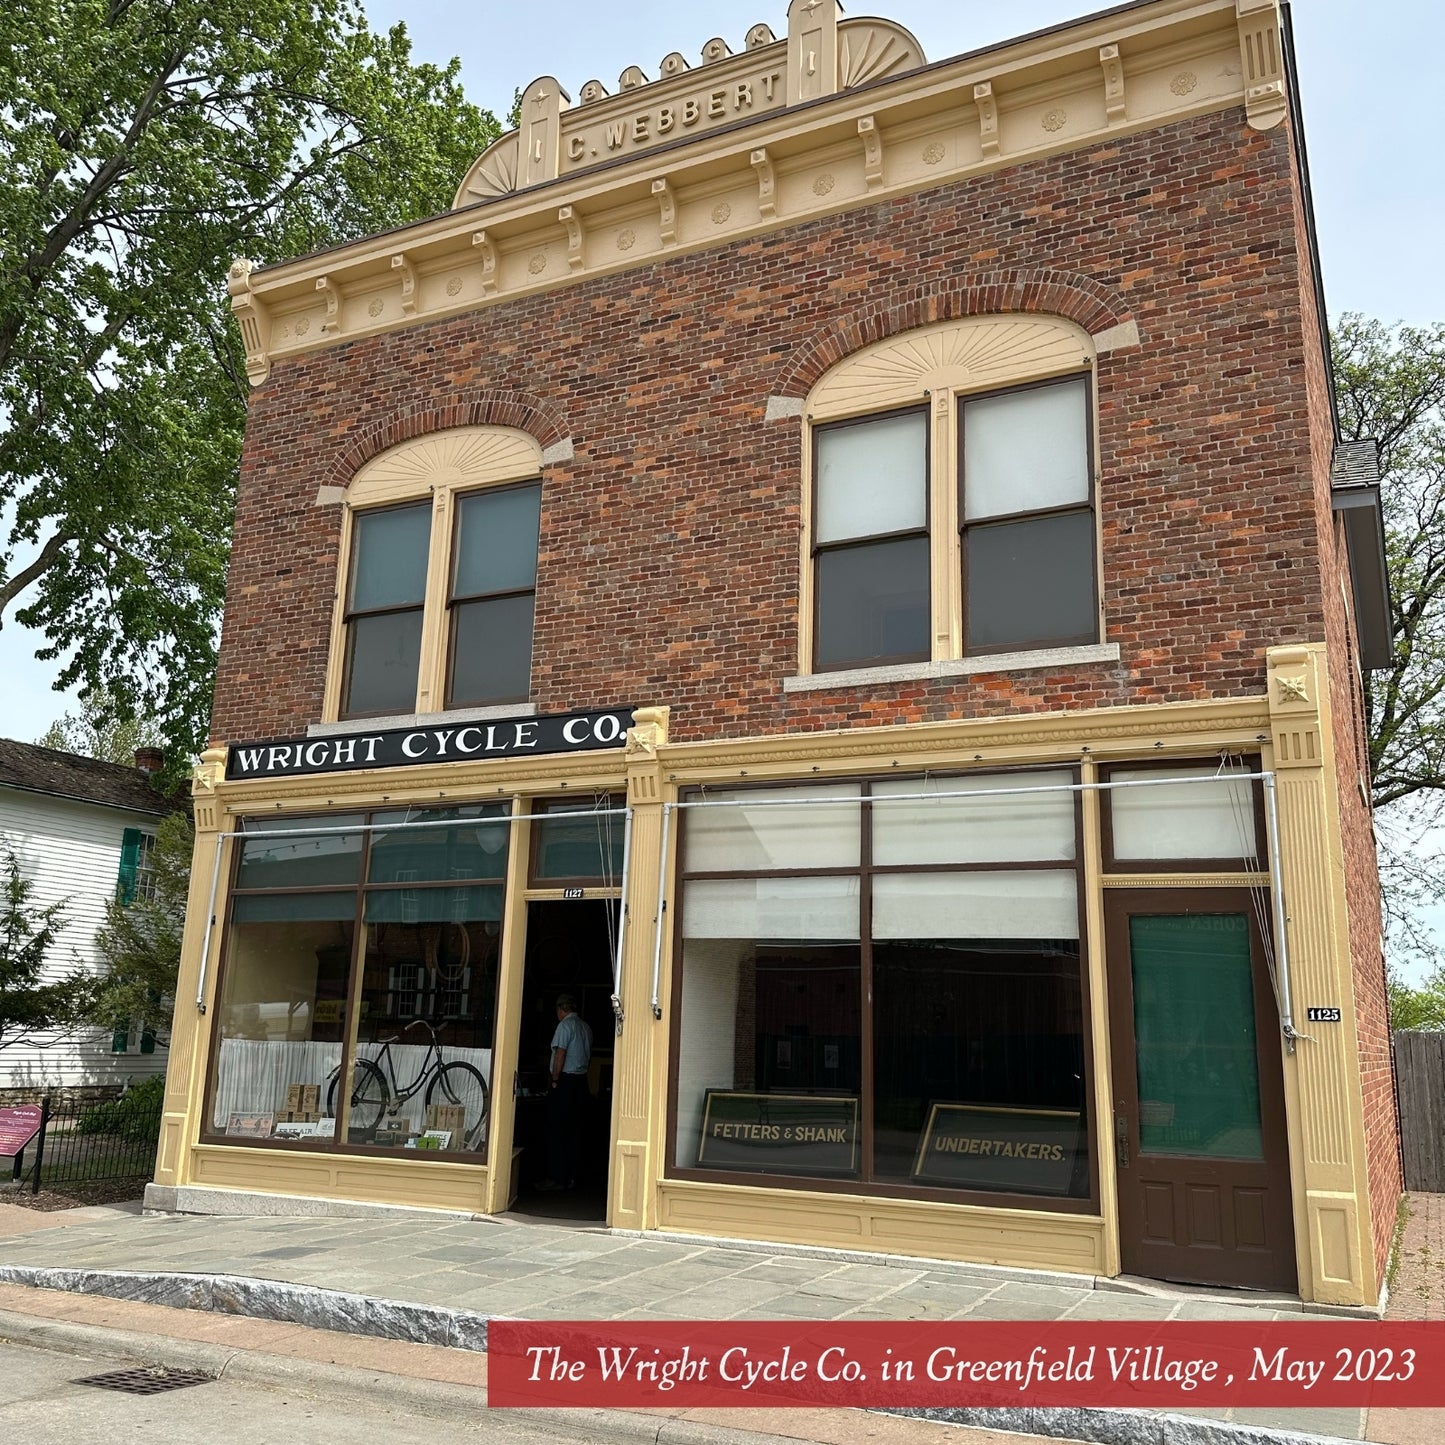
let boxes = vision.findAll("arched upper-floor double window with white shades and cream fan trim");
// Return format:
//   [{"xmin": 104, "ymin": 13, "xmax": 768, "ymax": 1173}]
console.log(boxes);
[{"xmin": 802, "ymin": 316, "xmax": 1100, "ymax": 672}]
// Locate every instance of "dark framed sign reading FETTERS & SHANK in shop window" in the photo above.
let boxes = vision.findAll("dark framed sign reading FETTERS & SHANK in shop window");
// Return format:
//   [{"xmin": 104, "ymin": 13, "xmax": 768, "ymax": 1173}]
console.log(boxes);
[{"xmin": 698, "ymin": 1088, "xmax": 858, "ymax": 1175}]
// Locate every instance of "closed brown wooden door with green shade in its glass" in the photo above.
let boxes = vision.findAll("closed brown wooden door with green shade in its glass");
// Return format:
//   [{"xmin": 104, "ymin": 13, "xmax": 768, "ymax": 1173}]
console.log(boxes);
[{"xmin": 1104, "ymin": 889, "xmax": 1296, "ymax": 1289}]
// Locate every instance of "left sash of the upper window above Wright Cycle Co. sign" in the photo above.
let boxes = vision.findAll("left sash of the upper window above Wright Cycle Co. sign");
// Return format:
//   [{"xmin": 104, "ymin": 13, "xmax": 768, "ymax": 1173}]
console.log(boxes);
[{"xmin": 341, "ymin": 501, "xmax": 432, "ymax": 717}]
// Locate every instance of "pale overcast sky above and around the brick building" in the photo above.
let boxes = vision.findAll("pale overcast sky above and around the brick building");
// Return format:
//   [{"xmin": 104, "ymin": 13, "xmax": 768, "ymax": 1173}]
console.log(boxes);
[{"xmin": 0, "ymin": 0, "xmax": 1445, "ymax": 867}]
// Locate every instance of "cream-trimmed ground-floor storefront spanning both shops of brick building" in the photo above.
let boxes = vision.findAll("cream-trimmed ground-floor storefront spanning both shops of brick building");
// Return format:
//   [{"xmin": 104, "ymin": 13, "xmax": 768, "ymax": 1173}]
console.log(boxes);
[{"xmin": 155, "ymin": 649, "xmax": 1373, "ymax": 1302}]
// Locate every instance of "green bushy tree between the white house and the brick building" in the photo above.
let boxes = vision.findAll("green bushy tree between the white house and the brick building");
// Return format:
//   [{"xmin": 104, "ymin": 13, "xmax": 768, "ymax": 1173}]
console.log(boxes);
[{"xmin": 87, "ymin": 814, "xmax": 195, "ymax": 1043}]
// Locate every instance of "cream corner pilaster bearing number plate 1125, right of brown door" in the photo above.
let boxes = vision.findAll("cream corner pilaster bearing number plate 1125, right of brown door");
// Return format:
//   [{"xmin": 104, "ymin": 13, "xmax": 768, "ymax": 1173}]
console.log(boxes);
[{"xmin": 1269, "ymin": 643, "xmax": 1379, "ymax": 1305}]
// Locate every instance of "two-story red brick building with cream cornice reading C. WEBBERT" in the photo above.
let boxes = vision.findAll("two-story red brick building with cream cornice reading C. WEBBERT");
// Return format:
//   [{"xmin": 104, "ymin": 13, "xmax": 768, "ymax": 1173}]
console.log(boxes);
[{"xmin": 156, "ymin": 0, "xmax": 1400, "ymax": 1305}]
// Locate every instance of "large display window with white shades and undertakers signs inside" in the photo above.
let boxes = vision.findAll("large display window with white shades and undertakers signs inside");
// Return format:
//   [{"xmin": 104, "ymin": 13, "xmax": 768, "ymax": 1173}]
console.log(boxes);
[{"xmin": 669, "ymin": 769, "xmax": 1097, "ymax": 1209}]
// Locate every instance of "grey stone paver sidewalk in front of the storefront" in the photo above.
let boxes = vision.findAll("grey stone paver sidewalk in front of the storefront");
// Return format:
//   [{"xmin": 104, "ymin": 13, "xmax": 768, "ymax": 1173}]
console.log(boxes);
[{"xmin": 0, "ymin": 1204, "xmax": 1396, "ymax": 1439}]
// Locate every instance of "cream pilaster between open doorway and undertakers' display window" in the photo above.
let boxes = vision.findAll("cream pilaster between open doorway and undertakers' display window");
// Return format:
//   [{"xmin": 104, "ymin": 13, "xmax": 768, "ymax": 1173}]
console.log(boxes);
[{"xmin": 607, "ymin": 708, "xmax": 668, "ymax": 1230}]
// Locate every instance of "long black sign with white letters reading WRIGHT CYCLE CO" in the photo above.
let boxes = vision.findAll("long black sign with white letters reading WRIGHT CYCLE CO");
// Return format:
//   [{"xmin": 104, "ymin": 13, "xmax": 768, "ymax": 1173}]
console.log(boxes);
[{"xmin": 225, "ymin": 707, "xmax": 633, "ymax": 782}]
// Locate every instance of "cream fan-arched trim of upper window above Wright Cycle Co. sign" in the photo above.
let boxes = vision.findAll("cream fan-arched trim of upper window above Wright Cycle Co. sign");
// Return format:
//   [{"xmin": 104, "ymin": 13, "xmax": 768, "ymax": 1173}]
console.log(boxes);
[{"xmin": 321, "ymin": 426, "xmax": 542, "ymax": 723}]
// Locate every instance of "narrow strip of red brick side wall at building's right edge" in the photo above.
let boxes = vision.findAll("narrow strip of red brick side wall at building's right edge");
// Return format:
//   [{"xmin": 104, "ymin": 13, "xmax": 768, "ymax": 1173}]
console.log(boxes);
[{"xmin": 1295, "ymin": 115, "xmax": 1405, "ymax": 1280}]
